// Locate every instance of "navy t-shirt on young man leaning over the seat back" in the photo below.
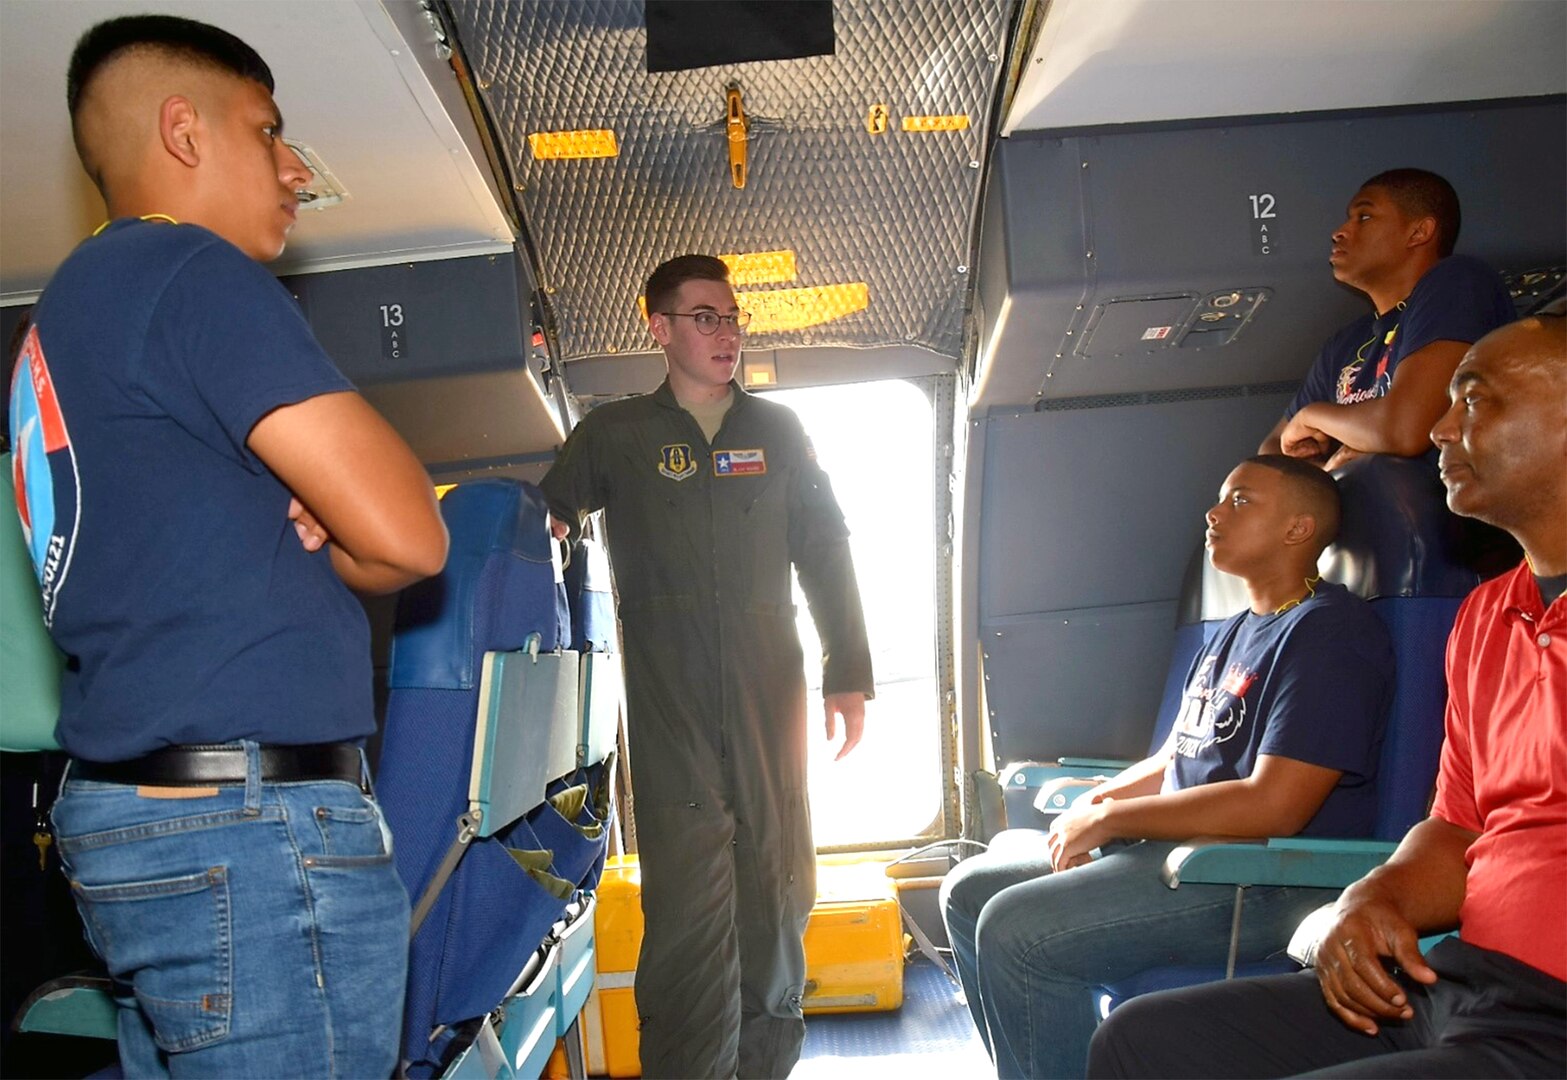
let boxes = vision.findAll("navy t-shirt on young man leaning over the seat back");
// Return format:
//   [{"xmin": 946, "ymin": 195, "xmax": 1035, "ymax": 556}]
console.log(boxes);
[{"xmin": 1285, "ymin": 256, "xmax": 1517, "ymax": 417}]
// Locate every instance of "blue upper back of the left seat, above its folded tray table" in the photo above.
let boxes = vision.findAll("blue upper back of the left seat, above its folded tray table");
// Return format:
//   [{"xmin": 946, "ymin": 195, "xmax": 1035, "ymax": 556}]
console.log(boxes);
[{"xmin": 387, "ymin": 478, "xmax": 561, "ymax": 690}]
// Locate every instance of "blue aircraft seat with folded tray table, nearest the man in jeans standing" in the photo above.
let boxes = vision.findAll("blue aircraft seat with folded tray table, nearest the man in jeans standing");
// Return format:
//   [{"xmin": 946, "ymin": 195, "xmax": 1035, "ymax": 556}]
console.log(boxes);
[{"xmin": 378, "ymin": 480, "xmax": 613, "ymax": 1075}]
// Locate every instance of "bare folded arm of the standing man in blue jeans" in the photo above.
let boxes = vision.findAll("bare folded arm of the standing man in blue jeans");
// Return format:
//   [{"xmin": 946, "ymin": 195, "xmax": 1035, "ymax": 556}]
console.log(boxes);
[{"xmin": 248, "ymin": 392, "xmax": 447, "ymax": 593}]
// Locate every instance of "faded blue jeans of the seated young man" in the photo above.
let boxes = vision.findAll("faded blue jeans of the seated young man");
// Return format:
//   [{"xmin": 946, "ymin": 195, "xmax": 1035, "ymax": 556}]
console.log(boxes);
[{"xmin": 942, "ymin": 829, "xmax": 1334, "ymax": 1077}]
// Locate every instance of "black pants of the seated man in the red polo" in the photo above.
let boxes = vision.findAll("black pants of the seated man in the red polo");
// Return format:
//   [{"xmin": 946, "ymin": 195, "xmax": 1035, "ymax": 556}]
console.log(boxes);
[{"xmin": 1087, "ymin": 937, "xmax": 1567, "ymax": 1078}]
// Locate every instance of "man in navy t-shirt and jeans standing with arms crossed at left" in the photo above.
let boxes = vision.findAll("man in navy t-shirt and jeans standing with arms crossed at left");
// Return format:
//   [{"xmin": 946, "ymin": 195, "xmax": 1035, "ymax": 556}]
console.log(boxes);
[{"xmin": 11, "ymin": 16, "xmax": 447, "ymax": 1077}]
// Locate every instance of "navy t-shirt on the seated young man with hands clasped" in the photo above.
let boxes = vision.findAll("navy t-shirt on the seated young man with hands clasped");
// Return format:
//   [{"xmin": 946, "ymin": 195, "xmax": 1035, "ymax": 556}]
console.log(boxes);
[{"xmin": 1164, "ymin": 582, "xmax": 1393, "ymax": 837}]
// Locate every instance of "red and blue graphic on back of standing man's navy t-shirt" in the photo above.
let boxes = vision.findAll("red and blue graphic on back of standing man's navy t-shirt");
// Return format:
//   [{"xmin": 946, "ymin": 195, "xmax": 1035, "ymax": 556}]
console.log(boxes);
[{"xmin": 11, "ymin": 326, "xmax": 81, "ymax": 625}]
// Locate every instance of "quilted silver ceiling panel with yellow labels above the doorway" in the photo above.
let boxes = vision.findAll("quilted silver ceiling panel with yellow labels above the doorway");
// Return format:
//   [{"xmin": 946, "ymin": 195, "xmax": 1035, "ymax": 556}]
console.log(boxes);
[{"xmin": 451, "ymin": 0, "xmax": 1012, "ymax": 359}]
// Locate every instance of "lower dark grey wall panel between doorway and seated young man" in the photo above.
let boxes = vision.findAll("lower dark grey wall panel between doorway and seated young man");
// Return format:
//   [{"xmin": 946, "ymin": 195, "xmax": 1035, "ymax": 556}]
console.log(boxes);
[{"xmin": 981, "ymin": 602, "xmax": 1175, "ymax": 763}]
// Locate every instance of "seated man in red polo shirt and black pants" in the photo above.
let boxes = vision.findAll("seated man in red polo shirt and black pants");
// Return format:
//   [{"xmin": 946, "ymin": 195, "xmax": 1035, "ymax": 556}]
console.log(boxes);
[{"xmin": 1089, "ymin": 315, "xmax": 1567, "ymax": 1077}]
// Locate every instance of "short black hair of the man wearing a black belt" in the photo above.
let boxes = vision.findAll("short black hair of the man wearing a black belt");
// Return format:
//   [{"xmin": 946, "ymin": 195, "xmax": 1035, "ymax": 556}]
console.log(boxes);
[{"xmin": 66, "ymin": 16, "xmax": 276, "ymax": 121}]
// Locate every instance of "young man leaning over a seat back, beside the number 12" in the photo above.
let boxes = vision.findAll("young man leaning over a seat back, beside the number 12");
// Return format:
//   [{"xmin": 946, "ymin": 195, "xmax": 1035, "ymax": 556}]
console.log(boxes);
[{"xmin": 1258, "ymin": 169, "xmax": 1514, "ymax": 469}]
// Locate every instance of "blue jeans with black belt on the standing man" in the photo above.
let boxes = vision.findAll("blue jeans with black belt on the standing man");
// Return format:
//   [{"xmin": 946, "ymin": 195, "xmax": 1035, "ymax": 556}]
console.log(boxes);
[{"xmin": 53, "ymin": 743, "xmax": 407, "ymax": 1077}]
